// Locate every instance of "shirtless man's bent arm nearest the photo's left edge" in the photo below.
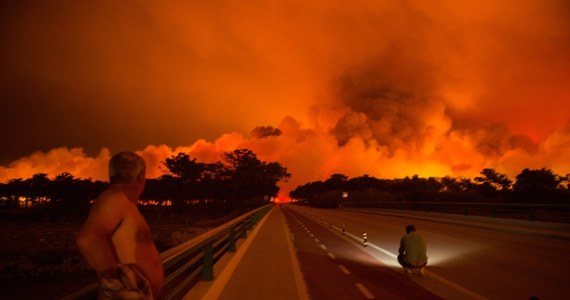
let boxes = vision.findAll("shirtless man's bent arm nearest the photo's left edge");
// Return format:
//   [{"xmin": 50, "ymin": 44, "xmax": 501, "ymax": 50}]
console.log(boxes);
[{"xmin": 76, "ymin": 193, "xmax": 129, "ymax": 278}]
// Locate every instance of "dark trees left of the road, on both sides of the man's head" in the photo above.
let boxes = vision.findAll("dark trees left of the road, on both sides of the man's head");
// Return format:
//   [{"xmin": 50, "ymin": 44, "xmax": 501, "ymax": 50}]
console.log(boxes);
[{"xmin": 0, "ymin": 149, "xmax": 291, "ymax": 219}]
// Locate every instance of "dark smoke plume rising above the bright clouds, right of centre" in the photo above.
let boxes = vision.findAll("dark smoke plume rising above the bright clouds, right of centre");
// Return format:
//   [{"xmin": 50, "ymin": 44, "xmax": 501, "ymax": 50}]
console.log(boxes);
[{"xmin": 331, "ymin": 57, "xmax": 451, "ymax": 155}]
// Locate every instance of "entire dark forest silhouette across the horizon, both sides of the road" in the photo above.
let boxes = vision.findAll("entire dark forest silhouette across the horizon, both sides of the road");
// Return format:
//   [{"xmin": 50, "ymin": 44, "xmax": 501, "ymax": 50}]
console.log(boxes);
[{"xmin": 0, "ymin": 149, "xmax": 570, "ymax": 220}]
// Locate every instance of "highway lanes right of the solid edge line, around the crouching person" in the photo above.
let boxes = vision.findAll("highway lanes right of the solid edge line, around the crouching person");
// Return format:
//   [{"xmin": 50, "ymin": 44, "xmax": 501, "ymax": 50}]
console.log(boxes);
[{"xmin": 282, "ymin": 205, "xmax": 570, "ymax": 299}]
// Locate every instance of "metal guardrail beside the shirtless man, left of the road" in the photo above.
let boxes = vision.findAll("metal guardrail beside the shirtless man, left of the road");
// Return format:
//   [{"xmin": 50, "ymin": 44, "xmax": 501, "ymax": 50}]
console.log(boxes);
[{"xmin": 63, "ymin": 205, "xmax": 272, "ymax": 300}]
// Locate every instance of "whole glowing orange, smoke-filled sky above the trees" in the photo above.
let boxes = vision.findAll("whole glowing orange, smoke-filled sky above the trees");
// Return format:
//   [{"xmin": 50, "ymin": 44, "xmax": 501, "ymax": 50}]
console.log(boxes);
[{"xmin": 0, "ymin": 0, "xmax": 570, "ymax": 189}]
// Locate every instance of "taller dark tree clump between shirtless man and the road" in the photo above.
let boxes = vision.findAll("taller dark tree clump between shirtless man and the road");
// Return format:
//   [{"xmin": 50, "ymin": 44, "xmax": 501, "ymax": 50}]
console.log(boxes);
[{"xmin": 141, "ymin": 149, "xmax": 291, "ymax": 206}]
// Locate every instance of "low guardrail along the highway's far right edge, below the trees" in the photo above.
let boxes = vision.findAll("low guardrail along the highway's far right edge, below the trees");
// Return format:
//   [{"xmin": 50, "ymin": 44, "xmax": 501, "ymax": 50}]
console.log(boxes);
[{"xmin": 340, "ymin": 201, "xmax": 570, "ymax": 223}]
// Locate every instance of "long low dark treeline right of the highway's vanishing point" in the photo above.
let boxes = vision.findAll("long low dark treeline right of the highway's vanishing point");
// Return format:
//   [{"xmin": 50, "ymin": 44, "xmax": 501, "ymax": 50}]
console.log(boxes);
[{"xmin": 290, "ymin": 168, "xmax": 570, "ymax": 208}]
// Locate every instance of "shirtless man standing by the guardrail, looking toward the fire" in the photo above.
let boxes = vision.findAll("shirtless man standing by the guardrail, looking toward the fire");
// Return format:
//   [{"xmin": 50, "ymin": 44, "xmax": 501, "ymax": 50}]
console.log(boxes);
[{"xmin": 76, "ymin": 152, "xmax": 164, "ymax": 299}]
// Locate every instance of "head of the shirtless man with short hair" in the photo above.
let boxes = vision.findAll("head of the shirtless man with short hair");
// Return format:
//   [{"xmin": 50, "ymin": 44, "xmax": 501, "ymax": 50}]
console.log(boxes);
[{"xmin": 109, "ymin": 151, "xmax": 146, "ymax": 183}]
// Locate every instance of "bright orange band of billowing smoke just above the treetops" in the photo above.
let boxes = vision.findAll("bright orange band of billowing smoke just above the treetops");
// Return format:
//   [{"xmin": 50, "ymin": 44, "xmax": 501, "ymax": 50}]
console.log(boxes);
[{"xmin": 0, "ymin": 117, "xmax": 570, "ymax": 192}]
